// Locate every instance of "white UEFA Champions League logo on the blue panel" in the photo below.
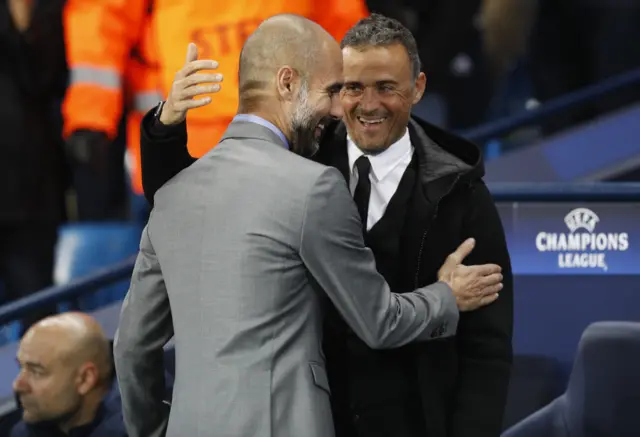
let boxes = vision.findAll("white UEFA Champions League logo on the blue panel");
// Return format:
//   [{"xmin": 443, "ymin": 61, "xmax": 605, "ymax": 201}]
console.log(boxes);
[{"xmin": 536, "ymin": 208, "xmax": 629, "ymax": 272}]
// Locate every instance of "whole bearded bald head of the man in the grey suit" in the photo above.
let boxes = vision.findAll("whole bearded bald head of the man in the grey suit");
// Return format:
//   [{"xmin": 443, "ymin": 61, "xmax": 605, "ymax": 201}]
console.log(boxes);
[{"xmin": 238, "ymin": 14, "xmax": 342, "ymax": 157}]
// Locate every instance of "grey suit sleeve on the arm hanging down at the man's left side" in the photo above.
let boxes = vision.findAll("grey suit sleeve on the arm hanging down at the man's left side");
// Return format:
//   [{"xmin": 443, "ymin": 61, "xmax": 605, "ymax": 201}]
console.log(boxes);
[{"xmin": 114, "ymin": 227, "xmax": 173, "ymax": 437}]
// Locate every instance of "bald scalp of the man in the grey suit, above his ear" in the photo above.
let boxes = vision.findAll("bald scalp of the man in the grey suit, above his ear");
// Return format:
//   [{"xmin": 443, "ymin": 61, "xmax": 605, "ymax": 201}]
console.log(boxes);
[{"xmin": 239, "ymin": 14, "xmax": 339, "ymax": 97}]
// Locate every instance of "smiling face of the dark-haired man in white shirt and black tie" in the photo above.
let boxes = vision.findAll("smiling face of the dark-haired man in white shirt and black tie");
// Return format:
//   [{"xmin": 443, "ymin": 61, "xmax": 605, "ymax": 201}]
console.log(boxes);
[{"xmin": 340, "ymin": 43, "xmax": 426, "ymax": 154}]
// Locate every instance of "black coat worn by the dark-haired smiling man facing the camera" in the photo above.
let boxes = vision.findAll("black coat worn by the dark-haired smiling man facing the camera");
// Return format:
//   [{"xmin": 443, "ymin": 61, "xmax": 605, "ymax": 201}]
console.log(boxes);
[{"xmin": 136, "ymin": 111, "xmax": 513, "ymax": 437}]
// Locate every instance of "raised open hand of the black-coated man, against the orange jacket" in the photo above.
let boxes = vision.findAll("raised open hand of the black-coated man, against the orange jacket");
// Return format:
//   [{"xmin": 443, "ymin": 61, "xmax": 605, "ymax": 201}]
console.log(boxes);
[{"xmin": 159, "ymin": 43, "xmax": 223, "ymax": 126}]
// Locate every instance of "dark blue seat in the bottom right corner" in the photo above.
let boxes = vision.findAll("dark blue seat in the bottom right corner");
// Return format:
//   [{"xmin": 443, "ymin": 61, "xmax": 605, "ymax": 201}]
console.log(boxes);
[{"xmin": 502, "ymin": 322, "xmax": 640, "ymax": 437}]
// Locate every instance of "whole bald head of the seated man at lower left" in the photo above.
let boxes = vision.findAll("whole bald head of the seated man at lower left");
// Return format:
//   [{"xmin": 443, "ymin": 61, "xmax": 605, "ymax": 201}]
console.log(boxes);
[{"xmin": 13, "ymin": 313, "xmax": 112, "ymax": 424}]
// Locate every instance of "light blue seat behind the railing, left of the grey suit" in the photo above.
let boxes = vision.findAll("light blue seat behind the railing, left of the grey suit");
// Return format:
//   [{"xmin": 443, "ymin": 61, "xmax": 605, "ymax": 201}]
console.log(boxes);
[{"xmin": 54, "ymin": 222, "xmax": 142, "ymax": 312}]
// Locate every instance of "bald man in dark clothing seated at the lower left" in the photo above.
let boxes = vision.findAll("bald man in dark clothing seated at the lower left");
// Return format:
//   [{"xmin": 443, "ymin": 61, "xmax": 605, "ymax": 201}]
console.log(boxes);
[{"xmin": 11, "ymin": 313, "xmax": 127, "ymax": 437}]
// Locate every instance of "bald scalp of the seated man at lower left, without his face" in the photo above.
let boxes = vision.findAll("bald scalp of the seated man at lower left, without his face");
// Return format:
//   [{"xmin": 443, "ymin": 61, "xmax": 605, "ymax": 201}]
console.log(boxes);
[{"xmin": 22, "ymin": 312, "xmax": 112, "ymax": 381}]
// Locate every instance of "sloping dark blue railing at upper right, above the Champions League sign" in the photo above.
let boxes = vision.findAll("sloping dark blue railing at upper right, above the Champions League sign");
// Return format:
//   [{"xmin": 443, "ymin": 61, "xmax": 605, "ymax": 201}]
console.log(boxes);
[{"xmin": 460, "ymin": 68, "xmax": 640, "ymax": 144}]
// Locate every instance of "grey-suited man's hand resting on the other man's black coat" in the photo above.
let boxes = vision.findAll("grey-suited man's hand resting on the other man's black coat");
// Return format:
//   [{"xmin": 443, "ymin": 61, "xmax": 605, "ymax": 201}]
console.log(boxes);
[{"xmin": 438, "ymin": 238, "xmax": 503, "ymax": 311}]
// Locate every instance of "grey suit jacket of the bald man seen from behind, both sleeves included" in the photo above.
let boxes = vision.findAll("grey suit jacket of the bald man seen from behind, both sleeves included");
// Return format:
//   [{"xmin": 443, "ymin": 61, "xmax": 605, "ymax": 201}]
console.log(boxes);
[{"xmin": 114, "ymin": 122, "xmax": 458, "ymax": 437}]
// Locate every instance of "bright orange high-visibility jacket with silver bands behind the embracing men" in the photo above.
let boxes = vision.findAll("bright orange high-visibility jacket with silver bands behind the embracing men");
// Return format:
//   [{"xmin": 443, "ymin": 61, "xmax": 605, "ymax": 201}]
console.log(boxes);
[{"xmin": 63, "ymin": 0, "xmax": 368, "ymax": 194}]
